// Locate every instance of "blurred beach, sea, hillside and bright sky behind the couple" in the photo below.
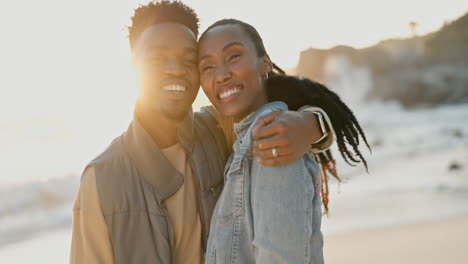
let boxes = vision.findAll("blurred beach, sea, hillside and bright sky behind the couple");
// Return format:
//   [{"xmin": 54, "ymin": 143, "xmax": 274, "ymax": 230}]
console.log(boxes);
[{"xmin": 0, "ymin": 0, "xmax": 468, "ymax": 263}]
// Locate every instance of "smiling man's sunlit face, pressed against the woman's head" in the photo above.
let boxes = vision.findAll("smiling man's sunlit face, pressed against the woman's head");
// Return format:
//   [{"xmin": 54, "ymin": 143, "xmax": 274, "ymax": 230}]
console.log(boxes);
[{"xmin": 133, "ymin": 23, "xmax": 200, "ymax": 120}]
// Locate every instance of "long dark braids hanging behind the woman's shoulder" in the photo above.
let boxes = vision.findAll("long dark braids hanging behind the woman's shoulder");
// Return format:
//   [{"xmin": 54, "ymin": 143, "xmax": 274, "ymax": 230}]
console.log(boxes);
[{"xmin": 267, "ymin": 71, "xmax": 370, "ymax": 214}]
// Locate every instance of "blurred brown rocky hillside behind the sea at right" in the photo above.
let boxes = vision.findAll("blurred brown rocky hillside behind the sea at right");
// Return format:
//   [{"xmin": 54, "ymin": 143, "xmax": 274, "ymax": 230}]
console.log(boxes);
[{"xmin": 296, "ymin": 13, "xmax": 468, "ymax": 107}]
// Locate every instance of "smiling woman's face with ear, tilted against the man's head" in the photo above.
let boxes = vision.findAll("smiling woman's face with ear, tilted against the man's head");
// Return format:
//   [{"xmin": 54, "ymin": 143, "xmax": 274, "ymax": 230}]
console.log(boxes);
[{"xmin": 198, "ymin": 25, "xmax": 271, "ymax": 120}]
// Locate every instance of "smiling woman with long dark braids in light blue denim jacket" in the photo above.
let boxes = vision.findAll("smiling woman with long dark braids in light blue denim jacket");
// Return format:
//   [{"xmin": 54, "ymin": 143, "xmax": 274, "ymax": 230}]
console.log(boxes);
[{"xmin": 199, "ymin": 19, "xmax": 370, "ymax": 263}]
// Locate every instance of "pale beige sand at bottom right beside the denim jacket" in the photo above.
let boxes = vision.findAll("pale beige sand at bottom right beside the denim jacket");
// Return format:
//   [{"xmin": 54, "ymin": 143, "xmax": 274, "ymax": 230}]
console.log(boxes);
[{"xmin": 324, "ymin": 215, "xmax": 468, "ymax": 264}]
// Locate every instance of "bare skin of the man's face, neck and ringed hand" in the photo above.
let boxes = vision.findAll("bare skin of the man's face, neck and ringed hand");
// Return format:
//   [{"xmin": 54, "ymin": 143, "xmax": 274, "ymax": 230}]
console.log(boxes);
[{"xmin": 132, "ymin": 23, "xmax": 321, "ymax": 163}]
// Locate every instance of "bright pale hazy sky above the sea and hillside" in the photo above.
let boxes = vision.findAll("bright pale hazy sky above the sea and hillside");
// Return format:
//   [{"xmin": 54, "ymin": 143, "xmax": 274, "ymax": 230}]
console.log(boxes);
[{"xmin": 0, "ymin": 0, "xmax": 468, "ymax": 119}]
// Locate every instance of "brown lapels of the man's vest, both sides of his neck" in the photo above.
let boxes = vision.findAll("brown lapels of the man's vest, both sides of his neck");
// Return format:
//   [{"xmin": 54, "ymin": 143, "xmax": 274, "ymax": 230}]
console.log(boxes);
[{"xmin": 123, "ymin": 111, "xmax": 194, "ymax": 204}]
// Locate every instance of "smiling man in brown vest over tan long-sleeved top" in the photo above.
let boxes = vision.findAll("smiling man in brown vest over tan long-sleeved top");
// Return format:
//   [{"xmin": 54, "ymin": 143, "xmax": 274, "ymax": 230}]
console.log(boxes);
[{"xmin": 70, "ymin": 1, "xmax": 329, "ymax": 263}]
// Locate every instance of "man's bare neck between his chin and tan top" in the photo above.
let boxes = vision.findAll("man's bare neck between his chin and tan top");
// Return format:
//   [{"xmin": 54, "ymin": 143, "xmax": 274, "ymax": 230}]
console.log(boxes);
[{"xmin": 135, "ymin": 103, "xmax": 177, "ymax": 149}]
